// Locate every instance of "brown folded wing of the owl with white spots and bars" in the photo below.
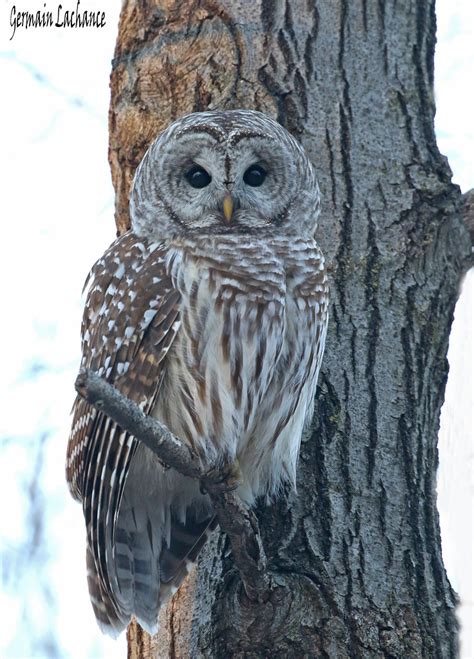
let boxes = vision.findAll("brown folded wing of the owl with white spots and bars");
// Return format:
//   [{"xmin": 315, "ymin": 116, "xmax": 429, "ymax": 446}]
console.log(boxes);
[{"xmin": 66, "ymin": 232, "xmax": 180, "ymax": 636}]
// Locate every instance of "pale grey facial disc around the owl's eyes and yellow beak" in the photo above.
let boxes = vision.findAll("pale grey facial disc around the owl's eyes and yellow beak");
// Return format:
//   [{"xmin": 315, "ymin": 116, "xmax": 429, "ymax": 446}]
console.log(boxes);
[{"xmin": 160, "ymin": 133, "xmax": 296, "ymax": 233}]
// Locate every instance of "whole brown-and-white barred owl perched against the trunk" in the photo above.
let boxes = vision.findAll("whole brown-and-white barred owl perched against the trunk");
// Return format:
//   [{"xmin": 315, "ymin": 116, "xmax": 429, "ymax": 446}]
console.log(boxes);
[{"xmin": 67, "ymin": 110, "xmax": 328, "ymax": 635}]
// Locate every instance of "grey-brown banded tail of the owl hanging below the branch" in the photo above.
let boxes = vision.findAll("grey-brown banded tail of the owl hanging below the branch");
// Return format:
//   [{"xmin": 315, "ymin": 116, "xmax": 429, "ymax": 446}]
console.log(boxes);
[{"xmin": 87, "ymin": 501, "xmax": 216, "ymax": 638}]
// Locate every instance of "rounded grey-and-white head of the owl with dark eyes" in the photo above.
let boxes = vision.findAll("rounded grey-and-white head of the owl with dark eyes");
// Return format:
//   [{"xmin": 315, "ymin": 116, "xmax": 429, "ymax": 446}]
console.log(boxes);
[{"xmin": 130, "ymin": 110, "xmax": 320, "ymax": 239}]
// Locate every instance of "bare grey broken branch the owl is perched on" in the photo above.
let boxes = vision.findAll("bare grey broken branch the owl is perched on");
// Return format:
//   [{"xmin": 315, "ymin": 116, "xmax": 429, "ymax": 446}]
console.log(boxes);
[{"xmin": 75, "ymin": 370, "xmax": 270, "ymax": 601}]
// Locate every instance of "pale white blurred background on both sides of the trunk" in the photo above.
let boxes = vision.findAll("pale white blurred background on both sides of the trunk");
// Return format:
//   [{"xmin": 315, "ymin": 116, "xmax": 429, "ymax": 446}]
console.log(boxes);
[{"xmin": 0, "ymin": 0, "xmax": 474, "ymax": 659}]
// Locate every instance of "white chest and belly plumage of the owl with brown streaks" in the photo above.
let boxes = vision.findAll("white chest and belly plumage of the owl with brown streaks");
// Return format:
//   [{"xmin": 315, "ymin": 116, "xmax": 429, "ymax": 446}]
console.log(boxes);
[{"xmin": 153, "ymin": 236, "xmax": 327, "ymax": 504}]
